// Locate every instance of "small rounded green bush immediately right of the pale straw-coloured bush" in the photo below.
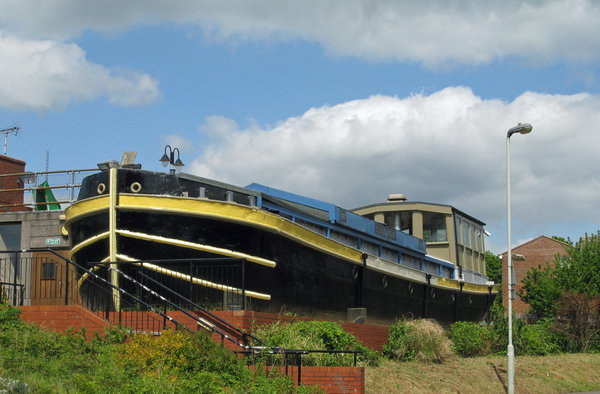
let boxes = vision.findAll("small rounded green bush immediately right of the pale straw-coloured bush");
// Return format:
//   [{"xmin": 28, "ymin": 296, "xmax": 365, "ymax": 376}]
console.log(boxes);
[{"xmin": 450, "ymin": 321, "xmax": 490, "ymax": 357}]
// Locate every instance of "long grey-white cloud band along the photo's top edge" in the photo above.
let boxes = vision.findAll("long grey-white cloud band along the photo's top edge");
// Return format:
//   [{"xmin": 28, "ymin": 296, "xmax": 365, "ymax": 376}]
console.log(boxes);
[{"xmin": 0, "ymin": 0, "xmax": 600, "ymax": 68}]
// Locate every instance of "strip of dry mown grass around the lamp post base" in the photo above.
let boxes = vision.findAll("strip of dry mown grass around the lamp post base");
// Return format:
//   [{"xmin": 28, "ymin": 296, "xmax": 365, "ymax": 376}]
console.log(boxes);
[{"xmin": 365, "ymin": 354, "xmax": 600, "ymax": 394}]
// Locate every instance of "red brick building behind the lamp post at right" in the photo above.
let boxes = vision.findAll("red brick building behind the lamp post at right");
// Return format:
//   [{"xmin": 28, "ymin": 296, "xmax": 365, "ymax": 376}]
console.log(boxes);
[{"xmin": 502, "ymin": 235, "xmax": 569, "ymax": 316}]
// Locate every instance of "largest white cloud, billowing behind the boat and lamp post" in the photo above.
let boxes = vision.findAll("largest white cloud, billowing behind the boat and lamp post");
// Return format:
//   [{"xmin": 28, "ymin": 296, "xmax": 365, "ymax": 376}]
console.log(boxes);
[{"xmin": 187, "ymin": 87, "xmax": 600, "ymax": 252}]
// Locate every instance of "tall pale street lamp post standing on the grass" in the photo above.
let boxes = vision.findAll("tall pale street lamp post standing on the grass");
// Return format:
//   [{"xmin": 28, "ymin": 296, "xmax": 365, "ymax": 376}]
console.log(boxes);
[{"xmin": 506, "ymin": 123, "xmax": 533, "ymax": 394}]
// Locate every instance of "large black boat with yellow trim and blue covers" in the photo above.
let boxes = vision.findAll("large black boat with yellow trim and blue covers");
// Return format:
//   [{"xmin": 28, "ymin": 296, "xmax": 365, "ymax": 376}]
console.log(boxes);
[{"xmin": 63, "ymin": 155, "xmax": 499, "ymax": 324}]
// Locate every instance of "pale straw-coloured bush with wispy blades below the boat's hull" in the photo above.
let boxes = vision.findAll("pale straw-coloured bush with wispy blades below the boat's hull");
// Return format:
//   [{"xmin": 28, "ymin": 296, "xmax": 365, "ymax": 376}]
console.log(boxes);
[{"xmin": 383, "ymin": 319, "xmax": 453, "ymax": 363}]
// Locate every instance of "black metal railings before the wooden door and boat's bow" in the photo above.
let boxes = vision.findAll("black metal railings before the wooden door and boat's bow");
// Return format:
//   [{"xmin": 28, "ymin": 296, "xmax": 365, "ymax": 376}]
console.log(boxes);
[{"xmin": 0, "ymin": 249, "xmax": 255, "ymax": 347}]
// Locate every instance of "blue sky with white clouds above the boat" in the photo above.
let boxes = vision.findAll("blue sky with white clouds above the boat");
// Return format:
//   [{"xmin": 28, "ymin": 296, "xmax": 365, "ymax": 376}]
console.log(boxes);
[{"xmin": 0, "ymin": 0, "xmax": 600, "ymax": 253}]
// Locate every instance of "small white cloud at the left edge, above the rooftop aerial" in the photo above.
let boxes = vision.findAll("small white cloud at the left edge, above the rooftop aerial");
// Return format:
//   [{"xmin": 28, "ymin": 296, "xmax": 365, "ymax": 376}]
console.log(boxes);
[{"xmin": 0, "ymin": 31, "xmax": 160, "ymax": 111}]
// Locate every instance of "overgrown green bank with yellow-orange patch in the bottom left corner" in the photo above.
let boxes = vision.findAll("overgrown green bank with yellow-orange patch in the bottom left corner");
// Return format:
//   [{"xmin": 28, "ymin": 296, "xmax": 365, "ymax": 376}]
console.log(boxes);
[{"xmin": 0, "ymin": 302, "xmax": 311, "ymax": 393}]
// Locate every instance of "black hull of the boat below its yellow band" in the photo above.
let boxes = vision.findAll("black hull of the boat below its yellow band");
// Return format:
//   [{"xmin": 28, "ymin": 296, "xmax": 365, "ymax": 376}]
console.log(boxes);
[{"xmin": 71, "ymin": 210, "xmax": 495, "ymax": 324}]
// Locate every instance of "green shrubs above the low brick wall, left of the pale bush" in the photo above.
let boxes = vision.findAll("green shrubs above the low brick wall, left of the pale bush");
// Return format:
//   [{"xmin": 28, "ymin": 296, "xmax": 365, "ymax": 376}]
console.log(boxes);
[{"xmin": 255, "ymin": 321, "xmax": 379, "ymax": 366}]
